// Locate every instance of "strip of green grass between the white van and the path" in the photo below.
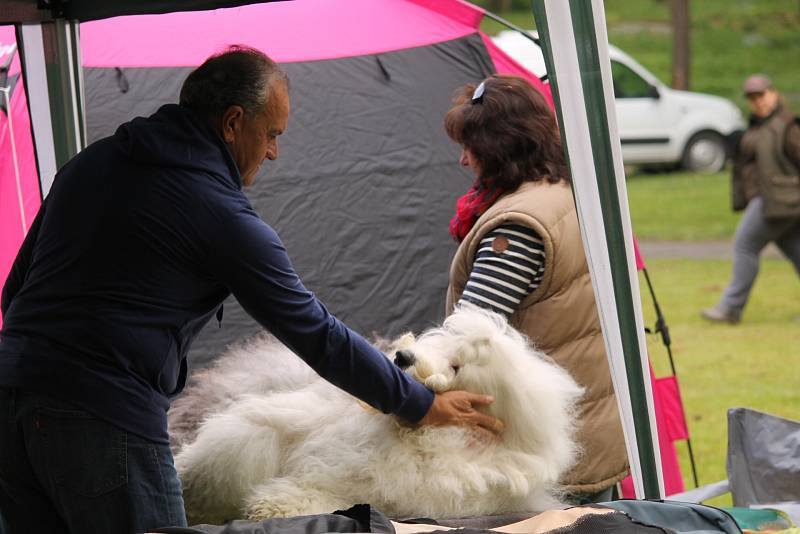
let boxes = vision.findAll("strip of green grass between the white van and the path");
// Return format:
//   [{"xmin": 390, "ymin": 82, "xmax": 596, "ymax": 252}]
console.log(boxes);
[{"xmin": 627, "ymin": 172, "xmax": 739, "ymax": 241}]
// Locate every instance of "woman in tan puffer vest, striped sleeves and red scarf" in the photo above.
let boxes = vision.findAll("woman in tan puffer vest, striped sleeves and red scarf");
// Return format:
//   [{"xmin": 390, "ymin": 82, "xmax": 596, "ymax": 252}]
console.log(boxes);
[{"xmin": 445, "ymin": 75, "xmax": 628, "ymax": 503}]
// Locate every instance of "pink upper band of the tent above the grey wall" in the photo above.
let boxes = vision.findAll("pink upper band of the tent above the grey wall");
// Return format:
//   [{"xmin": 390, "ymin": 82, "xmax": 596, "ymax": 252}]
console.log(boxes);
[{"xmin": 81, "ymin": 0, "xmax": 482, "ymax": 67}]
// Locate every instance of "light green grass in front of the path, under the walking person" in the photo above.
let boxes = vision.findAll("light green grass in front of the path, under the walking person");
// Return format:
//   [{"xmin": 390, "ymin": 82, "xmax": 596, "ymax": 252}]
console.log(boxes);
[{"xmin": 640, "ymin": 259, "xmax": 800, "ymax": 506}]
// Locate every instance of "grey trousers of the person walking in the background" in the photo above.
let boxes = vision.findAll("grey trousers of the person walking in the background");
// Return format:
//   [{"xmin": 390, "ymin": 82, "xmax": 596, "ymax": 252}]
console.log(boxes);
[{"xmin": 719, "ymin": 197, "xmax": 800, "ymax": 314}]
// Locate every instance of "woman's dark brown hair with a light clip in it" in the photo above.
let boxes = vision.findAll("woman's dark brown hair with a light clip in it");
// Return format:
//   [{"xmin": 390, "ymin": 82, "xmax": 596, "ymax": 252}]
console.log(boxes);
[{"xmin": 444, "ymin": 75, "xmax": 569, "ymax": 191}]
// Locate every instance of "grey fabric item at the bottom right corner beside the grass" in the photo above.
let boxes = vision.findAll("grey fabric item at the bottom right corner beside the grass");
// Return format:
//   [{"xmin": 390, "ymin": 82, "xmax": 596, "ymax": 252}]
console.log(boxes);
[{"xmin": 727, "ymin": 408, "xmax": 800, "ymax": 506}]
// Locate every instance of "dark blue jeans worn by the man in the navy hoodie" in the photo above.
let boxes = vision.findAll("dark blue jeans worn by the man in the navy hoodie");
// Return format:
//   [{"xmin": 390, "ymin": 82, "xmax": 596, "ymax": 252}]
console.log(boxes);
[{"xmin": 0, "ymin": 387, "xmax": 186, "ymax": 534}]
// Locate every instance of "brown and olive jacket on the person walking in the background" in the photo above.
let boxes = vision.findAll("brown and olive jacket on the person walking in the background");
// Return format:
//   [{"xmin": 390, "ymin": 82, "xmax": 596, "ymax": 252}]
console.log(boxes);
[{"xmin": 732, "ymin": 106, "xmax": 800, "ymax": 219}]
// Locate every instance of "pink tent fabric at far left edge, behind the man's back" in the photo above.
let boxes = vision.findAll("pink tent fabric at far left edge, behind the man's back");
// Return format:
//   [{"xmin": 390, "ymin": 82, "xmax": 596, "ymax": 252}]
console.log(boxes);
[{"xmin": 0, "ymin": 75, "xmax": 41, "ymax": 326}]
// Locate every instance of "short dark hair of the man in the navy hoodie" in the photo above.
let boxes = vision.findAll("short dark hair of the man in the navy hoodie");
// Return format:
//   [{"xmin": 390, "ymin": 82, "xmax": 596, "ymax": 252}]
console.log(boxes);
[{"xmin": 180, "ymin": 45, "xmax": 289, "ymax": 117}]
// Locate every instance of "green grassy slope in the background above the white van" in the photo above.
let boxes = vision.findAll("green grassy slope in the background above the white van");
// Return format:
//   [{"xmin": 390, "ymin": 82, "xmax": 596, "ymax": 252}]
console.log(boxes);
[{"xmin": 477, "ymin": 0, "xmax": 800, "ymax": 112}]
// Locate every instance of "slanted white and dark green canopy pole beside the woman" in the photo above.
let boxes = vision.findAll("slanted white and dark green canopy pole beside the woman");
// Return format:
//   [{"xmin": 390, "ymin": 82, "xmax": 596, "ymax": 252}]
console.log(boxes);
[{"xmin": 532, "ymin": 0, "xmax": 664, "ymax": 499}]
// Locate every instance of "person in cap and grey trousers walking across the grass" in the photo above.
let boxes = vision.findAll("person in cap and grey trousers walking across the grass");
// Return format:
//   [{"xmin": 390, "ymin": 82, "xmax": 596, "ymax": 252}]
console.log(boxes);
[{"xmin": 701, "ymin": 74, "xmax": 800, "ymax": 324}]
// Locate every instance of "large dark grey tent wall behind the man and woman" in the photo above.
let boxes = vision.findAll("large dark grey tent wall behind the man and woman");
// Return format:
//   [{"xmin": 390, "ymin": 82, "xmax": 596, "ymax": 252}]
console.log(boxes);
[{"xmin": 85, "ymin": 33, "xmax": 493, "ymax": 368}]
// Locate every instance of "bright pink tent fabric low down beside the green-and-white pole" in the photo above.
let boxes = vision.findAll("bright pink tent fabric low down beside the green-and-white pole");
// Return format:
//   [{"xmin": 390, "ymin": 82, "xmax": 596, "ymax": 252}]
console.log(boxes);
[{"xmin": 621, "ymin": 364, "xmax": 688, "ymax": 499}]
